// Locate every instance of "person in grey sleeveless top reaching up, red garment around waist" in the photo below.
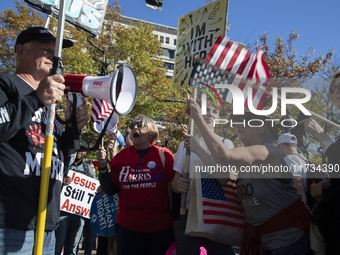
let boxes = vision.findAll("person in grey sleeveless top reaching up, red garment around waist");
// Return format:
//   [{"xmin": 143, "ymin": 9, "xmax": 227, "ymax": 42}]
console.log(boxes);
[{"xmin": 186, "ymin": 96, "xmax": 310, "ymax": 255}]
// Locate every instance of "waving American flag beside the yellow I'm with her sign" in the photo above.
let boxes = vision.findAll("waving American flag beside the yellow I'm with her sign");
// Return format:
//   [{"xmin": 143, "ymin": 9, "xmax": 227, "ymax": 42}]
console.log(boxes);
[{"xmin": 190, "ymin": 35, "xmax": 270, "ymax": 110}]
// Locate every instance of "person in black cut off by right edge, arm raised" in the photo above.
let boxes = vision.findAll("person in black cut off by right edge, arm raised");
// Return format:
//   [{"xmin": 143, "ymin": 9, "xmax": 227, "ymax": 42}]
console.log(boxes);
[{"xmin": 299, "ymin": 71, "xmax": 340, "ymax": 255}]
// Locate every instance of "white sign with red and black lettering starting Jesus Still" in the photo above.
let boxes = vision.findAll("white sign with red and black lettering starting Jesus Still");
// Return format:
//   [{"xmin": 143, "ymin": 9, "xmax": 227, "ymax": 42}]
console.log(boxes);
[{"xmin": 60, "ymin": 170, "xmax": 99, "ymax": 219}]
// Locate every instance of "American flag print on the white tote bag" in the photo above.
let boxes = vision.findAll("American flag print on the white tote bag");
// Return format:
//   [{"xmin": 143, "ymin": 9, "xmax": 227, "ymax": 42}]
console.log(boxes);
[{"xmin": 201, "ymin": 175, "xmax": 245, "ymax": 229}]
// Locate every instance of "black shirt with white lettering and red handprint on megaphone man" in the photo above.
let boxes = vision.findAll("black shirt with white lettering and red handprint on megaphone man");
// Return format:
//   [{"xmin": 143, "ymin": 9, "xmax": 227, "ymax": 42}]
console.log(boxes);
[{"xmin": 0, "ymin": 74, "xmax": 73, "ymax": 230}]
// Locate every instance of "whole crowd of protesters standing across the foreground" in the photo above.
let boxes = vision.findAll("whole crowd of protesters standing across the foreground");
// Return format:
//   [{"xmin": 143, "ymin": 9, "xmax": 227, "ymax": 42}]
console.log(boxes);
[{"xmin": 0, "ymin": 27, "xmax": 340, "ymax": 255}]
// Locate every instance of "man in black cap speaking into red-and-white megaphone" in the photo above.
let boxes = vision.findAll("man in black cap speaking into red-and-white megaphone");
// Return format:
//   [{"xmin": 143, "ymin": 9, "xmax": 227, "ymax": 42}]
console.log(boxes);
[{"xmin": 0, "ymin": 27, "xmax": 89, "ymax": 254}]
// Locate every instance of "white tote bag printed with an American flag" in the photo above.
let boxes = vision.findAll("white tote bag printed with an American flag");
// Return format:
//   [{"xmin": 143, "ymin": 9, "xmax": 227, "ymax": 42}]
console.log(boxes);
[{"xmin": 185, "ymin": 172, "xmax": 246, "ymax": 246}]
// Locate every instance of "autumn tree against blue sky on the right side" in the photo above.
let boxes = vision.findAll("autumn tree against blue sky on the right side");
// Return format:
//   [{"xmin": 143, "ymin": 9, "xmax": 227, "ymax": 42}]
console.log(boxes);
[{"xmin": 255, "ymin": 31, "xmax": 340, "ymax": 164}]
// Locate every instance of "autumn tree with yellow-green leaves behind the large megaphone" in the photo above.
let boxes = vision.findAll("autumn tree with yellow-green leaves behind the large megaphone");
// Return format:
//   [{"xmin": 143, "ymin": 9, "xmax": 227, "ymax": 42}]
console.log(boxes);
[{"xmin": 0, "ymin": 1, "xmax": 188, "ymax": 155}]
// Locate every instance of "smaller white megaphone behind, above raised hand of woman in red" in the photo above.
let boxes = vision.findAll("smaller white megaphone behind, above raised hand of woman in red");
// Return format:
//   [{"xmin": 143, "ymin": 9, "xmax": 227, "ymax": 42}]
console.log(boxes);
[{"xmin": 93, "ymin": 113, "xmax": 125, "ymax": 149}]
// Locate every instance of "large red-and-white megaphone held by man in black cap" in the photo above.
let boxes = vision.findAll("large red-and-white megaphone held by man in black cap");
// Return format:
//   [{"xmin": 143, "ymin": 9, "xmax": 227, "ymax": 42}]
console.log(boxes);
[{"xmin": 64, "ymin": 64, "xmax": 137, "ymax": 115}]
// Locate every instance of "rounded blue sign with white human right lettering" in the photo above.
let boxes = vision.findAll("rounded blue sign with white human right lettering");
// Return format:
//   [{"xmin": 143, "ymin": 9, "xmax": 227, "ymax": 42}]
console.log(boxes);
[{"xmin": 91, "ymin": 192, "xmax": 118, "ymax": 236}]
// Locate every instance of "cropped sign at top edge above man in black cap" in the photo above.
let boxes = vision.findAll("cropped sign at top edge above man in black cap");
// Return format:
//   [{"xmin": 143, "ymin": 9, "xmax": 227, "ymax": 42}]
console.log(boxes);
[{"xmin": 25, "ymin": 0, "xmax": 108, "ymax": 38}]
